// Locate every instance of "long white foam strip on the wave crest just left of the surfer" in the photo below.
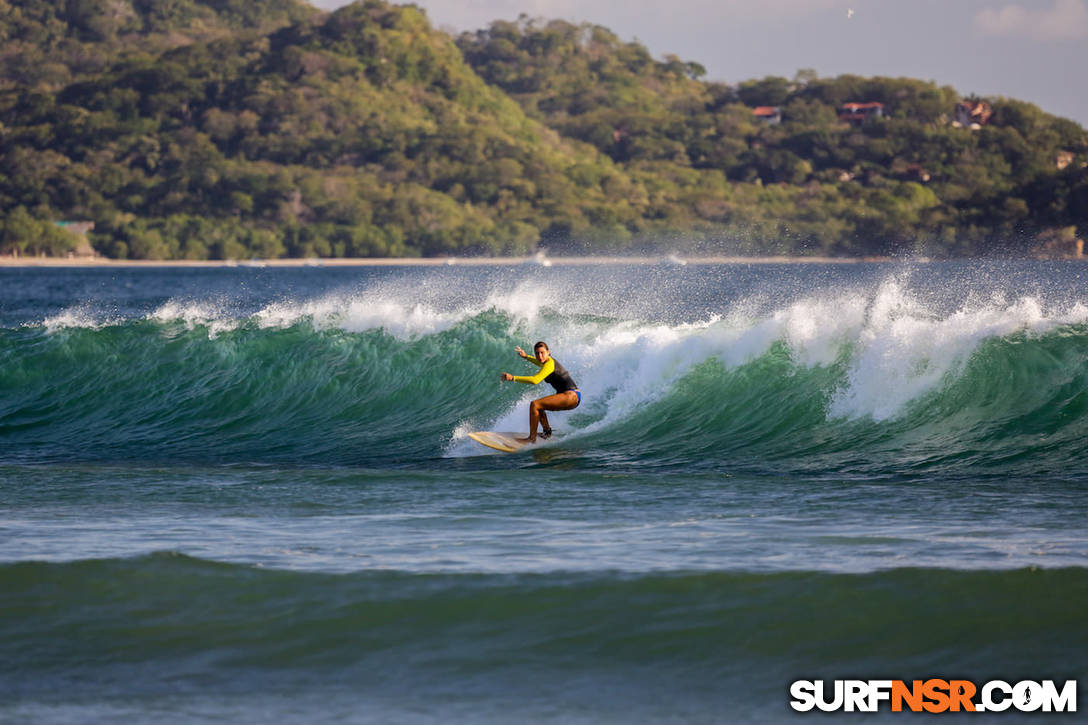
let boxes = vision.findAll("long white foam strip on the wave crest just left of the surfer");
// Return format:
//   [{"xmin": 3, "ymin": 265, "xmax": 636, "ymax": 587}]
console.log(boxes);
[{"xmin": 256, "ymin": 296, "xmax": 472, "ymax": 340}]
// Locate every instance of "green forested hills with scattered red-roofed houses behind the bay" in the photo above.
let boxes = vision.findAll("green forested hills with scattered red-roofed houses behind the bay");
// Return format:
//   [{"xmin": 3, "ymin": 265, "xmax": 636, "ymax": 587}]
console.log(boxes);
[{"xmin": 0, "ymin": 0, "xmax": 1088, "ymax": 258}]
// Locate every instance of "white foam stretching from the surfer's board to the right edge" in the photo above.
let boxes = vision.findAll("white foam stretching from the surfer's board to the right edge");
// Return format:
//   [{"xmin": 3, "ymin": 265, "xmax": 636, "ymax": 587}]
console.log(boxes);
[{"xmin": 447, "ymin": 280, "xmax": 1088, "ymax": 446}]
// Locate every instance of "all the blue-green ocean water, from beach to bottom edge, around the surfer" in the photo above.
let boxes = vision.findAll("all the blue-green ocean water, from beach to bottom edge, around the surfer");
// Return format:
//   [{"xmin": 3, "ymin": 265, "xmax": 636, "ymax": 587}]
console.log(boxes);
[{"xmin": 0, "ymin": 262, "xmax": 1088, "ymax": 724}]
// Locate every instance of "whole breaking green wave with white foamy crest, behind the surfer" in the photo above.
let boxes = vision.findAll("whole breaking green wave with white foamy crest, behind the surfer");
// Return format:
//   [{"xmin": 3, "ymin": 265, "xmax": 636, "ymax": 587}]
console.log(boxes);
[{"xmin": 6, "ymin": 272, "xmax": 1088, "ymax": 475}]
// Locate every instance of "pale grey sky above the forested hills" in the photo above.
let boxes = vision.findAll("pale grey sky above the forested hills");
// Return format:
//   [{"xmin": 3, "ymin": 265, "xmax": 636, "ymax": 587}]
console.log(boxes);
[{"xmin": 311, "ymin": 0, "xmax": 1088, "ymax": 126}]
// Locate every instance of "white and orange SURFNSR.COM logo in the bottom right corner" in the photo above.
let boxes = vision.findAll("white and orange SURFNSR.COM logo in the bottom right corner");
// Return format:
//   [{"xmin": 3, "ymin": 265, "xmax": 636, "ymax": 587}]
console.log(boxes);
[{"xmin": 790, "ymin": 679, "xmax": 1077, "ymax": 712}]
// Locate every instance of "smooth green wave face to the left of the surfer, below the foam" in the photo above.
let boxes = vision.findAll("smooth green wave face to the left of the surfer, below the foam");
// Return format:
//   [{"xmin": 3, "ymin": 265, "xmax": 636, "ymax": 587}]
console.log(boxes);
[{"xmin": 0, "ymin": 316, "xmax": 513, "ymax": 460}]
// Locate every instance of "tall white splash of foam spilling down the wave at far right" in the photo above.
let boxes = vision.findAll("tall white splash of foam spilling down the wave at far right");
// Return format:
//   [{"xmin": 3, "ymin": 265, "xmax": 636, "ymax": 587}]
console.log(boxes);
[{"xmin": 829, "ymin": 282, "xmax": 1088, "ymax": 421}]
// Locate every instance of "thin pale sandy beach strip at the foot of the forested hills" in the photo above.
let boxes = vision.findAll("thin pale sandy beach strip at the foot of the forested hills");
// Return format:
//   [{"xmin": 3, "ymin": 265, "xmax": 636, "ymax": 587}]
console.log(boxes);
[{"xmin": 0, "ymin": 256, "xmax": 905, "ymax": 269}]
